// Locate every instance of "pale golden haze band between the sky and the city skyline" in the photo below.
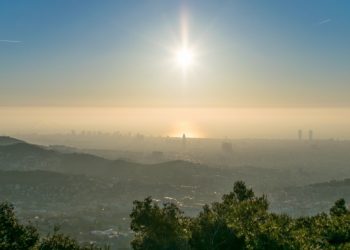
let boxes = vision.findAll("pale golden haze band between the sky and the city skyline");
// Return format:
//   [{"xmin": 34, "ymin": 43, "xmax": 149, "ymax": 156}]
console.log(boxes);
[{"xmin": 0, "ymin": 107, "xmax": 350, "ymax": 140}]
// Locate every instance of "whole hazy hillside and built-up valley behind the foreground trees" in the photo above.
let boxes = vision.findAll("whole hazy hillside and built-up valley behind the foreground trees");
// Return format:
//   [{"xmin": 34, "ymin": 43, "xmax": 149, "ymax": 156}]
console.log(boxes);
[{"xmin": 0, "ymin": 138, "xmax": 350, "ymax": 249}]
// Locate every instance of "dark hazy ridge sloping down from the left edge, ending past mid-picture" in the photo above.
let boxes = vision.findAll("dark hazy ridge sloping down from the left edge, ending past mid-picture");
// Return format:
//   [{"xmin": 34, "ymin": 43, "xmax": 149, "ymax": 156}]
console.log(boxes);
[{"xmin": 0, "ymin": 138, "xmax": 218, "ymax": 182}]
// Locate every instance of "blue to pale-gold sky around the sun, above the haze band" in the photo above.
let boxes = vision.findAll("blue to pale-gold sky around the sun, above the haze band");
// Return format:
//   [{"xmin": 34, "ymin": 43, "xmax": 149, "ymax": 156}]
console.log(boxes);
[{"xmin": 0, "ymin": 0, "xmax": 350, "ymax": 137}]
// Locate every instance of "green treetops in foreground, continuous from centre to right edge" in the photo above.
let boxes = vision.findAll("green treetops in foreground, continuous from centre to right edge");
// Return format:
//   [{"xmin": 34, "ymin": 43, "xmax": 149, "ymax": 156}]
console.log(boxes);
[{"xmin": 131, "ymin": 182, "xmax": 350, "ymax": 250}]
